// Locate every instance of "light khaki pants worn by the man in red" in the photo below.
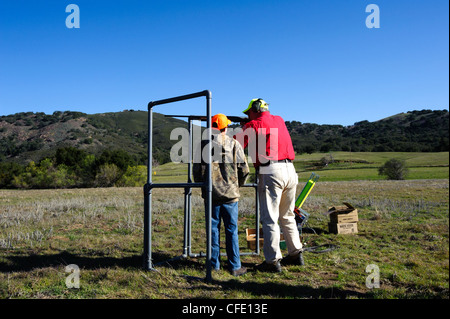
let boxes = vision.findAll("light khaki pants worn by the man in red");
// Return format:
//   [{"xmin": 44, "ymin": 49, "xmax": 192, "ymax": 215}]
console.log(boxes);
[{"xmin": 258, "ymin": 163, "xmax": 302, "ymax": 263}]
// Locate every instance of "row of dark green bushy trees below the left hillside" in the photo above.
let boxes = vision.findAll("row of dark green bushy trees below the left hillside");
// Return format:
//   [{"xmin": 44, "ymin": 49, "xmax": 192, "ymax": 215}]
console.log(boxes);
[{"xmin": 0, "ymin": 147, "xmax": 147, "ymax": 189}]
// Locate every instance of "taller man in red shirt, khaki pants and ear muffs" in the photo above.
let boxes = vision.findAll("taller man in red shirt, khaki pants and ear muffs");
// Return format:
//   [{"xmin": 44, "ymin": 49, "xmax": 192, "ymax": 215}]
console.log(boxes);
[{"xmin": 235, "ymin": 99, "xmax": 304, "ymax": 272}]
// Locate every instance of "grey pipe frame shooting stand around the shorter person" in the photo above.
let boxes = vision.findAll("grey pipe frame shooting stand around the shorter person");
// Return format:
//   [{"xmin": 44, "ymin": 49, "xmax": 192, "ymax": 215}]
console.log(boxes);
[{"xmin": 144, "ymin": 90, "xmax": 260, "ymax": 282}]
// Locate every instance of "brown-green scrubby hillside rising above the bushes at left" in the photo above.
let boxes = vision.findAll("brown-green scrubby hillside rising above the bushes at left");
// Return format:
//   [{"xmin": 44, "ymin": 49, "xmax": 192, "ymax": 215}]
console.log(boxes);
[{"xmin": 0, "ymin": 110, "xmax": 187, "ymax": 164}]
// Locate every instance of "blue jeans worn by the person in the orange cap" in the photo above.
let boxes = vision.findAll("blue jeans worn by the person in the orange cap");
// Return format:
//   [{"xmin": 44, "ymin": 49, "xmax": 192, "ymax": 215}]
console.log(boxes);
[{"xmin": 205, "ymin": 202, "xmax": 241, "ymax": 271}]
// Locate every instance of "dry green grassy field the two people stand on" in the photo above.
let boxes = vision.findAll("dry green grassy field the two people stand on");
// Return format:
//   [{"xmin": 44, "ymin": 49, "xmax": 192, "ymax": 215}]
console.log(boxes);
[{"xmin": 0, "ymin": 153, "xmax": 449, "ymax": 299}]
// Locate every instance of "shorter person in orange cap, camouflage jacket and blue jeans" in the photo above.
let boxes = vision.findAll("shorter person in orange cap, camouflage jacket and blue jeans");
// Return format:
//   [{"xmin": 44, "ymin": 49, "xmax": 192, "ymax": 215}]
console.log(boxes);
[{"xmin": 193, "ymin": 114, "xmax": 249, "ymax": 276}]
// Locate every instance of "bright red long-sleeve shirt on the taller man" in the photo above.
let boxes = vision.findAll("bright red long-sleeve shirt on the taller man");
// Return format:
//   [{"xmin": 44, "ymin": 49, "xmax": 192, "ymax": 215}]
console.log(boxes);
[{"xmin": 235, "ymin": 111, "xmax": 295, "ymax": 167}]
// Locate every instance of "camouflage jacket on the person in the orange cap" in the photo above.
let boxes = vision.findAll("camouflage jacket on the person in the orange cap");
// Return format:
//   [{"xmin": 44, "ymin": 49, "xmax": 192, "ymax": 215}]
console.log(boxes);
[{"xmin": 193, "ymin": 134, "xmax": 249, "ymax": 203}]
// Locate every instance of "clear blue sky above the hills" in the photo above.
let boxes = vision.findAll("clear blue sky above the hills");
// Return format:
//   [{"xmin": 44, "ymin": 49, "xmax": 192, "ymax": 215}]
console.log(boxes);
[{"xmin": 0, "ymin": 0, "xmax": 449, "ymax": 125}]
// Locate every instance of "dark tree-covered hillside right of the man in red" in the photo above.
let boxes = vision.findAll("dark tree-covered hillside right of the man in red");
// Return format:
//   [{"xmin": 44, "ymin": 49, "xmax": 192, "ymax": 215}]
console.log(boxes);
[{"xmin": 286, "ymin": 110, "xmax": 449, "ymax": 153}]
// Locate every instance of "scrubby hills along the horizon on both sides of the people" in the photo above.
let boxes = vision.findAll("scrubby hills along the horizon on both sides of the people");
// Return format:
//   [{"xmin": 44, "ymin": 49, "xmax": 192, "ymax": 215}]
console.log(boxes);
[{"xmin": 0, "ymin": 110, "xmax": 449, "ymax": 164}]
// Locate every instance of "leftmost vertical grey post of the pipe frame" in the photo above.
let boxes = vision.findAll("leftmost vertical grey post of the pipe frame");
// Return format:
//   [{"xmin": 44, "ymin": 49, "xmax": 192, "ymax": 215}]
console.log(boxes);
[{"xmin": 144, "ymin": 107, "xmax": 153, "ymax": 270}]
